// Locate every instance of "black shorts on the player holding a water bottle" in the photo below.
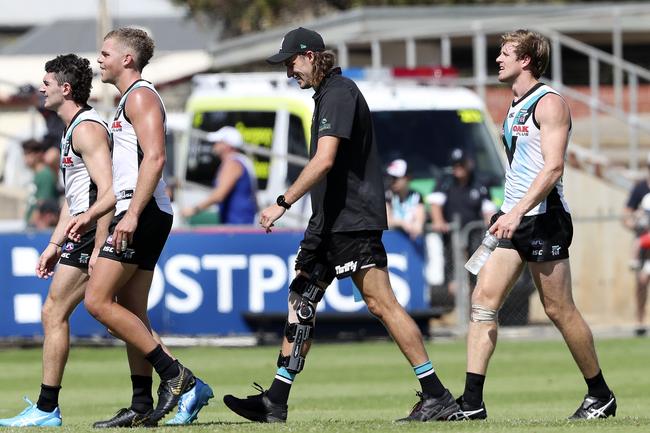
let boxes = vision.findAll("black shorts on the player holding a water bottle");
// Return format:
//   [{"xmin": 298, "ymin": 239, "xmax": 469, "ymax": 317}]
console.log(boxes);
[{"xmin": 490, "ymin": 208, "xmax": 573, "ymax": 262}]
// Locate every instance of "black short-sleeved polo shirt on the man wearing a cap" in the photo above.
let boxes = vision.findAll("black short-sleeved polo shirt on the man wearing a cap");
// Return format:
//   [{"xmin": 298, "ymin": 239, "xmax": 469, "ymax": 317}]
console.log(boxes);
[{"xmin": 307, "ymin": 68, "xmax": 387, "ymax": 233}]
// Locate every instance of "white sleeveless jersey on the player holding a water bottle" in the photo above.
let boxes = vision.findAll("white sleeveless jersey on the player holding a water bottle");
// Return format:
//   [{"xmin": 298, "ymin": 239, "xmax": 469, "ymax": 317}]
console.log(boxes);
[{"xmin": 501, "ymin": 83, "xmax": 571, "ymax": 216}]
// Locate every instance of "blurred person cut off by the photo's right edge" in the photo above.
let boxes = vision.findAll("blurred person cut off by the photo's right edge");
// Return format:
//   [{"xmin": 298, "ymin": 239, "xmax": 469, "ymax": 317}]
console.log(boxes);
[{"xmin": 623, "ymin": 155, "xmax": 650, "ymax": 337}]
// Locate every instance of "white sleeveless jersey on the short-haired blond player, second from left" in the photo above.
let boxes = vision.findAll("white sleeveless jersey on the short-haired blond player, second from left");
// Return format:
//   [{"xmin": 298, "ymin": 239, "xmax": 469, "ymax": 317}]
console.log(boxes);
[{"xmin": 111, "ymin": 80, "xmax": 174, "ymax": 215}]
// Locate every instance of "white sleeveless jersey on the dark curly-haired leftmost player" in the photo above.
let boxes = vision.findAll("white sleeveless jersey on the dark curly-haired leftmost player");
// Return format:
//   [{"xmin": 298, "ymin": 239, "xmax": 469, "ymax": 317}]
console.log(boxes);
[{"xmin": 59, "ymin": 106, "xmax": 111, "ymax": 215}]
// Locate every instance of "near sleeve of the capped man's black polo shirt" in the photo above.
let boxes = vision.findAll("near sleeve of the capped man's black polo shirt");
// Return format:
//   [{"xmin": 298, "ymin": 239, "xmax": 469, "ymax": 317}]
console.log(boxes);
[{"xmin": 315, "ymin": 87, "xmax": 357, "ymax": 139}]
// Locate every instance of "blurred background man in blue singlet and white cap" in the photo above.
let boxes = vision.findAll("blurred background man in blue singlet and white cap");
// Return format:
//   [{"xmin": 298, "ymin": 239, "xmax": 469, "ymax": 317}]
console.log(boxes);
[{"xmin": 182, "ymin": 126, "xmax": 257, "ymax": 224}]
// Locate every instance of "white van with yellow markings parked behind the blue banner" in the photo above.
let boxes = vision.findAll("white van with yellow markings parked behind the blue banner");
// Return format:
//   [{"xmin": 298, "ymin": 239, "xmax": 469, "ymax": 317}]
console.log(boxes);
[{"xmin": 175, "ymin": 72, "xmax": 504, "ymax": 228}]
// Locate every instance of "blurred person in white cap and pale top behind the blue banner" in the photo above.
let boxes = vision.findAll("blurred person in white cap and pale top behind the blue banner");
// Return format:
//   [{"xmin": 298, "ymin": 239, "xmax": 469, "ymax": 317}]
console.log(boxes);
[{"xmin": 386, "ymin": 159, "xmax": 426, "ymax": 240}]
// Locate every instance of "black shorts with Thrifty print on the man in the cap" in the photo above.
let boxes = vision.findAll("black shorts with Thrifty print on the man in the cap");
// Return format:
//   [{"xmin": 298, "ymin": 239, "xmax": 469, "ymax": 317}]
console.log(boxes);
[{"xmin": 296, "ymin": 230, "xmax": 388, "ymax": 284}]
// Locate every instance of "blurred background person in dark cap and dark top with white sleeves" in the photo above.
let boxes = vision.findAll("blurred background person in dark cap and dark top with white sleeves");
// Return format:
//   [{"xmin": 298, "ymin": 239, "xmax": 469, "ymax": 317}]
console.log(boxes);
[{"xmin": 427, "ymin": 148, "xmax": 496, "ymax": 293}]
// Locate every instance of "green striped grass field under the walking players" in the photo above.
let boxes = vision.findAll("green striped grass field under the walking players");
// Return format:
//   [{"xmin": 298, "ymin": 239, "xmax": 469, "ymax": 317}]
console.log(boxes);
[{"xmin": 0, "ymin": 339, "xmax": 650, "ymax": 433}]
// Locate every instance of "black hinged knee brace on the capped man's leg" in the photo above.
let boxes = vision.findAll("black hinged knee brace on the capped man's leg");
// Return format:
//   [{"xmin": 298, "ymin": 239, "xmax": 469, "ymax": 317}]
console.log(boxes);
[{"xmin": 277, "ymin": 265, "xmax": 325, "ymax": 373}]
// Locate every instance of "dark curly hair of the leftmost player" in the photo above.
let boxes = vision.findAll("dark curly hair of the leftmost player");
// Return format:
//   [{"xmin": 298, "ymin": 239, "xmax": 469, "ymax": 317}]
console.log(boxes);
[{"xmin": 45, "ymin": 54, "xmax": 93, "ymax": 105}]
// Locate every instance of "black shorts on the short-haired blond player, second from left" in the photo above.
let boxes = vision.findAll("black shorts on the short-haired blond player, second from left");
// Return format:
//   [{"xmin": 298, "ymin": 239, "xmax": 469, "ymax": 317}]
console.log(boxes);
[{"xmin": 99, "ymin": 199, "xmax": 174, "ymax": 271}]
